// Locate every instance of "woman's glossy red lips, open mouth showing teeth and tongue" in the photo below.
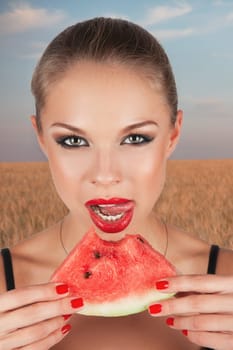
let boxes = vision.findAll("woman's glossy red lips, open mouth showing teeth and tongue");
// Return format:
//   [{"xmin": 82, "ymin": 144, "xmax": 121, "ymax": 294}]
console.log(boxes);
[{"xmin": 85, "ymin": 198, "xmax": 134, "ymax": 233}]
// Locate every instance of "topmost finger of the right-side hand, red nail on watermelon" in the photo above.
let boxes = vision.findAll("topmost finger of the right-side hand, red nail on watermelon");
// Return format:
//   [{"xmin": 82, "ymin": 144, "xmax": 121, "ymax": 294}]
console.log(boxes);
[{"xmin": 156, "ymin": 275, "xmax": 233, "ymax": 293}]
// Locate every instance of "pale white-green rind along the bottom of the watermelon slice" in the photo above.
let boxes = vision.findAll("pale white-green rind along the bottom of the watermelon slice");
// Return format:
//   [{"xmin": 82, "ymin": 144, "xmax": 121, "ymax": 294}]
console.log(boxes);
[{"xmin": 77, "ymin": 289, "xmax": 174, "ymax": 317}]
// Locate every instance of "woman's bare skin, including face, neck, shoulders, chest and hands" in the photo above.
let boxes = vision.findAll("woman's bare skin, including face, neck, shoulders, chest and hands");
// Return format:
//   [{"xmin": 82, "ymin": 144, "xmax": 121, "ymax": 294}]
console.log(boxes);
[{"xmin": 0, "ymin": 62, "xmax": 233, "ymax": 350}]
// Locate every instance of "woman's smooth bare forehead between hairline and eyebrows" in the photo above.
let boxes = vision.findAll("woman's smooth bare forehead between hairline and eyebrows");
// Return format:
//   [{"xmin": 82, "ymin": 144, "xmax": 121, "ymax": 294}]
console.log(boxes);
[{"xmin": 43, "ymin": 62, "xmax": 168, "ymax": 126}]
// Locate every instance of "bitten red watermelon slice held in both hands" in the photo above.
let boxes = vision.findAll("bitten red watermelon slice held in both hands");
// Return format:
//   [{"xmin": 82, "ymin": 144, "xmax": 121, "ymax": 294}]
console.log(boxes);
[{"xmin": 51, "ymin": 228, "xmax": 176, "ymax": 316}]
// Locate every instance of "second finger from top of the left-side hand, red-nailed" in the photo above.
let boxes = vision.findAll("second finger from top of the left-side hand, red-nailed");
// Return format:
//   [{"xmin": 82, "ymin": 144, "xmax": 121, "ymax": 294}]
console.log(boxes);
[{"xmin": 0, "ymin": 297, "xmax": 83, "ymax": 334}]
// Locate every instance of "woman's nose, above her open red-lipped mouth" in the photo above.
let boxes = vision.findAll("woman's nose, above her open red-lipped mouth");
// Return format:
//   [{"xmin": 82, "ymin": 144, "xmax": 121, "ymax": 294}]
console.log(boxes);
[{"xmin": 91, "ymin": 149, "xmax": 121, "ymax": 186}]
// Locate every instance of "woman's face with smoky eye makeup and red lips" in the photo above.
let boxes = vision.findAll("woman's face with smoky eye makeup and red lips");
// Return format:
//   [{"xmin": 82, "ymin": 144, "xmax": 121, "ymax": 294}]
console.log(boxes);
[{"xmin": 32, "ymin": 62, "xmax": 182, "ymax": 238}]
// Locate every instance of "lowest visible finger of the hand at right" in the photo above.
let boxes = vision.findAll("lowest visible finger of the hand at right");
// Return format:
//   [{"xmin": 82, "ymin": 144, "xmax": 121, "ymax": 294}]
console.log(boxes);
[{"xmin": 182, "ymin": 331, "xmax": 233, "ymax": 350}]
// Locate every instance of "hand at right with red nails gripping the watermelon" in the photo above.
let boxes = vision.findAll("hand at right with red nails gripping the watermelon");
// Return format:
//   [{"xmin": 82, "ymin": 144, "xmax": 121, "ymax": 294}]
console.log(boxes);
[{"xmin": 149, "ymin": 275, "xmax": 233, "ymax": 350}]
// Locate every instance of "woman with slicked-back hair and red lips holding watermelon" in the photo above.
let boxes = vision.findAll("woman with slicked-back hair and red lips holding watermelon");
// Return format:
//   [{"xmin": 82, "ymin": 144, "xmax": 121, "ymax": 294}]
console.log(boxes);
[{"xmin": 0, "ymin": 18, "xmax": 233, "ymax": 350}]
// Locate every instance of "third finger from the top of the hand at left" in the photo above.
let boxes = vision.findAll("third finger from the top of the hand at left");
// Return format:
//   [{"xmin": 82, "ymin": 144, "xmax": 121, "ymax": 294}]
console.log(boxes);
[{"xmin": 0, "ymin": 317, "xmax": 68, "ymax": 349}]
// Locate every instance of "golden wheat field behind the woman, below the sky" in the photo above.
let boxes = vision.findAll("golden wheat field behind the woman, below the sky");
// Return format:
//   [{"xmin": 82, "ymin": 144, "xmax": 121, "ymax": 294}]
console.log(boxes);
[{"xmin": 0, "ymin": 159, "xmax": 233, "ymax": 248}]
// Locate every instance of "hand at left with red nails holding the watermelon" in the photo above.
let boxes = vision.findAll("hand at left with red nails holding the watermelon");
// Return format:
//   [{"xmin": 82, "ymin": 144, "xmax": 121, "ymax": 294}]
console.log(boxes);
[{"xmin": 0, "ymin": 283, "xmax": 82, "ymax": 350}]
